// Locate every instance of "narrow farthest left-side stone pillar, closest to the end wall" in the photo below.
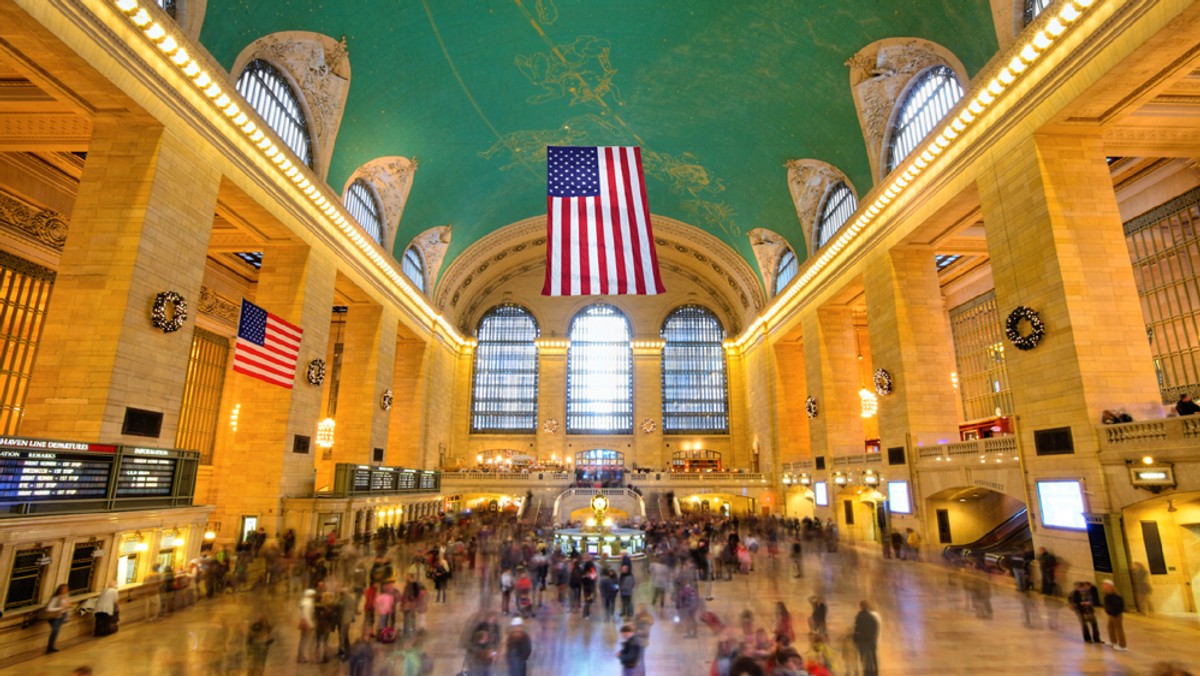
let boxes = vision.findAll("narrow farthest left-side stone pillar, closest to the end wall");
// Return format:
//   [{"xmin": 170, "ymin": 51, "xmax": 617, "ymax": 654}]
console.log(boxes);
[{"xmin": 380, "ymin": 337, "xmax": 428, "ymax": 467}]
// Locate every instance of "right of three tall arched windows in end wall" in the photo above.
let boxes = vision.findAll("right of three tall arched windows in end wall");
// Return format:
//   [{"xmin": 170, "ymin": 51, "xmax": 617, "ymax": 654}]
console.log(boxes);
[{"xmin": 662, "ymin": 305, "xmax": 730, "ymax": 435}]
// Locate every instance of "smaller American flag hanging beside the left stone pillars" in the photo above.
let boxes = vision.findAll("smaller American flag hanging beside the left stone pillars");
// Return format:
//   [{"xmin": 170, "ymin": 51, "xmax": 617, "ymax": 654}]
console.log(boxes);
[{"xmin": 233, "ymin": 299, "xmax": 304, "ymax": 389}]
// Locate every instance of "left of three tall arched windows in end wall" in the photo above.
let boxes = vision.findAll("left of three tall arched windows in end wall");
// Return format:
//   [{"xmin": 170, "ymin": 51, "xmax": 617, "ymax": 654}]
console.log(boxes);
[{"xmin": 470, "ymin": 305, "xmax": 538, "ymax": 433}]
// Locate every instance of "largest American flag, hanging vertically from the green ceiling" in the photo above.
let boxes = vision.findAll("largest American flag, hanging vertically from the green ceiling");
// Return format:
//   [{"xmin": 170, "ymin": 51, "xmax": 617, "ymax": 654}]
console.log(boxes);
[{"xmin": 541, "ymin": 145, "xmax": 666, "ymax": 295}]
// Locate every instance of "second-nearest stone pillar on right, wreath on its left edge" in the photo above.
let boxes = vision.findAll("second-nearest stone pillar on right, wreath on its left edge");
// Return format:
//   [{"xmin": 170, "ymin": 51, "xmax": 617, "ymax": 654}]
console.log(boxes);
[{"xmin": 863, "ymin": 247, "xmax": 959, "ymax": 449}]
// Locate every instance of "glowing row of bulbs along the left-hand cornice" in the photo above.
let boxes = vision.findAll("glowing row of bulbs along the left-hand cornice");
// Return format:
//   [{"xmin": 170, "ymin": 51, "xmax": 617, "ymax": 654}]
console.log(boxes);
[{"xmin": 113, "ymin": 0, "xmax": 475, "ymax": 348}]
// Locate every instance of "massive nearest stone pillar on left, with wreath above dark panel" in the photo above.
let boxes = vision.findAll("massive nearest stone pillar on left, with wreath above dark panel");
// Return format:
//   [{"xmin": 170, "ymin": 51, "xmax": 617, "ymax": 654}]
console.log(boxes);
[{"xmin": 20, "ymin": 116, "xmax": 221, "ymax": 445}]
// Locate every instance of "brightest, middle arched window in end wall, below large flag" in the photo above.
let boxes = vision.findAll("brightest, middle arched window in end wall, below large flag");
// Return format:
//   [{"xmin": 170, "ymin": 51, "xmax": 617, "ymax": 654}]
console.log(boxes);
[{"xmin": 566, "ymin": 304, "xmax": 634, "ymax": 435}]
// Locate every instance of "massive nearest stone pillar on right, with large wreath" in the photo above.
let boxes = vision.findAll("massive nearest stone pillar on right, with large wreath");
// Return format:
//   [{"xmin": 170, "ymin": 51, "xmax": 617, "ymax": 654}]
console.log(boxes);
[{"xmin": 978, "ymin": 131, "xmax": 1163, "ymax": 568}]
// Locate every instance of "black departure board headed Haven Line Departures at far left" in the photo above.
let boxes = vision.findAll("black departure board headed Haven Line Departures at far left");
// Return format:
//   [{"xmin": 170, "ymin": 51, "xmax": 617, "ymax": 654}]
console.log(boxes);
[{"xmin": 0, "ymin": 447, "xmax": 114, "ymax": 503}]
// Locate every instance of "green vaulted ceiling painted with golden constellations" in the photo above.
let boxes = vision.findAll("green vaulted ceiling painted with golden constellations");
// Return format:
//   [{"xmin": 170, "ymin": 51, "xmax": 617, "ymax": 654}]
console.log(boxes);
[{"xmin": 200, "ymin": 0, "xmax": 997, "ymax": 285}]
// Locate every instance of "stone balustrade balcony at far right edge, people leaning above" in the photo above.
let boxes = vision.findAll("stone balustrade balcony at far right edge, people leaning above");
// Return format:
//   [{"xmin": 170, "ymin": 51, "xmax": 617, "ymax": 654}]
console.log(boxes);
[{"xmin": 1096, "ymin": 415, "xmax": 1200, "ymax": 462}]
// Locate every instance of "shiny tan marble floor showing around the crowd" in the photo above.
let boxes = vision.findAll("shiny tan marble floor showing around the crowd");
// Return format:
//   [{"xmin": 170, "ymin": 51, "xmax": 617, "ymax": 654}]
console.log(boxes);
[{"xmin": 11, "ymin": 548, "xmax": 1200, "ymax": 676}]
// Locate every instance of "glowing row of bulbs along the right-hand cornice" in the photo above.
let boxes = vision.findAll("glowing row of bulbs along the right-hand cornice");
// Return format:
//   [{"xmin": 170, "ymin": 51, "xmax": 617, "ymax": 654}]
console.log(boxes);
[{"xmin": 725, "ymin": 0, "xmax": 1097, "ymax": 351}]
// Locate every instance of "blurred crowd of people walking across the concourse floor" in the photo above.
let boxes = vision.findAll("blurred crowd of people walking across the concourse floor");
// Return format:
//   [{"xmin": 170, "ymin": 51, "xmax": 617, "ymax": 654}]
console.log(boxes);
[{"xmin": 35, "ymin": 513, "xmax": 1183, "ymax": 676}]
